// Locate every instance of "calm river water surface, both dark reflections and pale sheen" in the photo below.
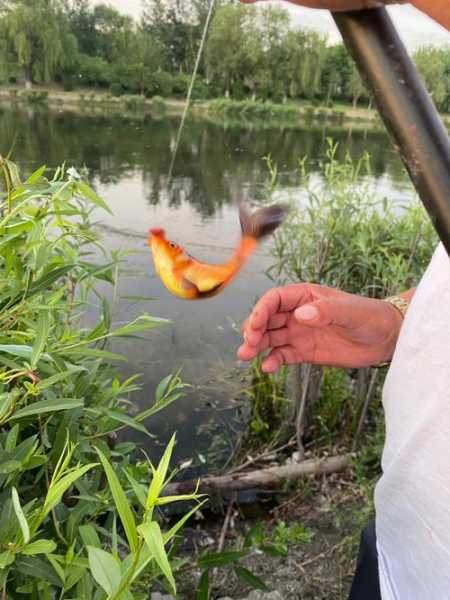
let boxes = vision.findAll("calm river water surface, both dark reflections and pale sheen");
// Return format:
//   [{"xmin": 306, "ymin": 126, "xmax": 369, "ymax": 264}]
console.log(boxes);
[{"xmin": 0, "ymin": 101, "xmax": 412, "ymax": 456}]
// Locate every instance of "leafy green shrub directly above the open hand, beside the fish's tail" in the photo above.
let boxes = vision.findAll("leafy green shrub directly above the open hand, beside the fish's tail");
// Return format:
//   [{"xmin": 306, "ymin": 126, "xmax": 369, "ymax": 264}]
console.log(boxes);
[{"xmin": 270, "ymin": 140, "xmax": 437, "ymax": 297}]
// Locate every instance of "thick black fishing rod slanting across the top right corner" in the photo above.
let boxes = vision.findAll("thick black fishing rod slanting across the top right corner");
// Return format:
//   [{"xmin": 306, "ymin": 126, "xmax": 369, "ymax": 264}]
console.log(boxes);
[{"xmin": 333, "ymin": 8, "xmax": 450, "ymax": 256}]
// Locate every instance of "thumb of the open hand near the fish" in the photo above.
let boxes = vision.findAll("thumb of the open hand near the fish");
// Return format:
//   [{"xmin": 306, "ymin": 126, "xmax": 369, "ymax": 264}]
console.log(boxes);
[{"xmin": 294, "ymin": 300, "xmax": 353, "ymax": 327}]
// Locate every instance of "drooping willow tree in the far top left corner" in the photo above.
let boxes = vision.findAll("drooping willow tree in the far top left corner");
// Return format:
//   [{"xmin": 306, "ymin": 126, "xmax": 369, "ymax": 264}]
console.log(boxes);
[{"xmin": 2, "ymin": 0, "xmax": 76, "ymax": 87}]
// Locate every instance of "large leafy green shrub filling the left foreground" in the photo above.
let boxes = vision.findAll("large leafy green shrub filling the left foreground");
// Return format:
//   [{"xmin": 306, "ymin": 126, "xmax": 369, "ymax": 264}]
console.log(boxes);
[{"xmin": 0, "ymin": 159, "xmax": 202, "ymax": 600}]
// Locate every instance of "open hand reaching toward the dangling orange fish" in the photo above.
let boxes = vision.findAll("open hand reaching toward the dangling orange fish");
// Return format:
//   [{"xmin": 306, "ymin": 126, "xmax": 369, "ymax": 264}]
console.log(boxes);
[{"xmin": 238, "ymin": 283, "xmax": 403, "ymax": 373}]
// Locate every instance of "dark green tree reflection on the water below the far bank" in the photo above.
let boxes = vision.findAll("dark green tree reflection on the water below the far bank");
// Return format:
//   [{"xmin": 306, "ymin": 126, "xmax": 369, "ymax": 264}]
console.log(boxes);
[{"xmin": 0, "ymin": 105, "xmax": 412, "ymax": 216}]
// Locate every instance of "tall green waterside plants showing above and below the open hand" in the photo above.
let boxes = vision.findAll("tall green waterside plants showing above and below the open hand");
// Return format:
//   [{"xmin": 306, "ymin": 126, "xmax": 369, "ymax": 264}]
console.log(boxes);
[{"xmin": 246, "ymin": 140, "xmax": 437, "ymax": 446}]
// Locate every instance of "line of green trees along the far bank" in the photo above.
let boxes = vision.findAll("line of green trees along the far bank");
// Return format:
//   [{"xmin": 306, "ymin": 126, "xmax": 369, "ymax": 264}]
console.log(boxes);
[{"xmin": 0, "ymin": 0, "xmax": 450, "ymax": 112}]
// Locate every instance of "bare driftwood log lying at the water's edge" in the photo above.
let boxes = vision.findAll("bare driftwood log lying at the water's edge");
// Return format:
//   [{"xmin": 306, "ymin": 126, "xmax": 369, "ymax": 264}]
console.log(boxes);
[{"xmin": 164, "ymin": 455, "xmax": 350, "ymax": 496}]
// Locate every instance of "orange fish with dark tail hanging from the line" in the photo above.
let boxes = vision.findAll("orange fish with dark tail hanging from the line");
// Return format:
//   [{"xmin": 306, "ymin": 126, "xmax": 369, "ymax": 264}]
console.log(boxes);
[{"xmin": 148, "ymin": 204, "xmax": 287, "ymax": 300}]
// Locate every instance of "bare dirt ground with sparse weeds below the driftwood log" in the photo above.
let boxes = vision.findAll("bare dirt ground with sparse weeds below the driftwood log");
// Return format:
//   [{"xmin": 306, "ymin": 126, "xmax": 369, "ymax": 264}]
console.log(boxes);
[{"xmin": 174, "ymin": 473, "xmax": 372, "ymax": 600}]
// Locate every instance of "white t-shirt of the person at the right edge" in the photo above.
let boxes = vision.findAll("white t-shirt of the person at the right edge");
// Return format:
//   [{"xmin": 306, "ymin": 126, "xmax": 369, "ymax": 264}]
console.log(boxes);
[{"xmin": 375, "ymin": 244, "xmax": 450, "ymax": 600}]
